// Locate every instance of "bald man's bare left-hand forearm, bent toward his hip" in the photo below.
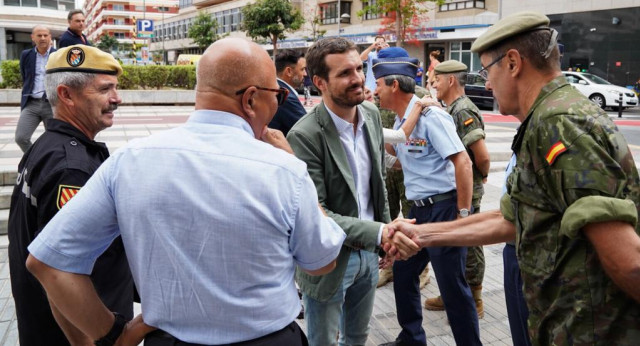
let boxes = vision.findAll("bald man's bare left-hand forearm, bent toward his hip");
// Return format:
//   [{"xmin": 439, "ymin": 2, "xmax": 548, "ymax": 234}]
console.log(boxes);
[{"xmin": 27, "ymin": 255, "xmax": 114, "ymax": 340}]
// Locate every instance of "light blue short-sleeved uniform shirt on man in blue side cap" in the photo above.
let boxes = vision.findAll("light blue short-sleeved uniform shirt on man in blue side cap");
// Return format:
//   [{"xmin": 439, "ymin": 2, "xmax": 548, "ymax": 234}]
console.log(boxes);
[{"xmin": 393, "ymin": 95, "xmax": 465, "ymax": 200}]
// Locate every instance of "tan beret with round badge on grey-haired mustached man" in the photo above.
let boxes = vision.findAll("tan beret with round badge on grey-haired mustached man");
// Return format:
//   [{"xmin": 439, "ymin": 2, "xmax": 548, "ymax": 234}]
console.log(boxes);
[{"xmin": 46, "ymin": 45, "xmax": 122, "ymax": 76}]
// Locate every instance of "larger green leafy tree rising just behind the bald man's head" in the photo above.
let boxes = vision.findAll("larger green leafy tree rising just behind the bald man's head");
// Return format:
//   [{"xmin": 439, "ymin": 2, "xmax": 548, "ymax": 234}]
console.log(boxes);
[{"xmin": 242, "ymin": 0, "xmax": 304, "ymax": 56}]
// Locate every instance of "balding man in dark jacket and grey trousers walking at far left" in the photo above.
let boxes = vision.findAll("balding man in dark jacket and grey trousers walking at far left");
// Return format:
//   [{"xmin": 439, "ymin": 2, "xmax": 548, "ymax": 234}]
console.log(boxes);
[{"xmin": 16, "ymin": 25, "xmax": 56, "ymax": 152}]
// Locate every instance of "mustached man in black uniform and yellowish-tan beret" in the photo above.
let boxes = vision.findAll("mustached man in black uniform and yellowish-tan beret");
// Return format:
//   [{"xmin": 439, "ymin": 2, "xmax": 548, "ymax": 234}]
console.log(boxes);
[{"xmin": 9, "ymin": 46, "xmax": 133, "ymax": 346}]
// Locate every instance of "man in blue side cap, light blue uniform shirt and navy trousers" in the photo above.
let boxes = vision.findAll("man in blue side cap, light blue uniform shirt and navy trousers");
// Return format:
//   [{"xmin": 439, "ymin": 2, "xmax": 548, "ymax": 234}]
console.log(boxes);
[{"xmin": 373, "ymin": 52, "xmax": 481, "ymax": 345}]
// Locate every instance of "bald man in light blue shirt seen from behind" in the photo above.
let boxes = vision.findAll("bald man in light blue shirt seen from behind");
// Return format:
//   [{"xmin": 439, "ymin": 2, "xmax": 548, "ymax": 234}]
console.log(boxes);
[{"xmin": 27, "ymin": 39, "xmax": 345, "ymax": 346}]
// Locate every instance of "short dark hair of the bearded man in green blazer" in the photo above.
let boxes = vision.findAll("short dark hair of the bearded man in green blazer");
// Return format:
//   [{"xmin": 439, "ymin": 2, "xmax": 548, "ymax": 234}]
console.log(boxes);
[{"xmin": 306, "ymin": 37, "xmax": 357, "ymax": 80}]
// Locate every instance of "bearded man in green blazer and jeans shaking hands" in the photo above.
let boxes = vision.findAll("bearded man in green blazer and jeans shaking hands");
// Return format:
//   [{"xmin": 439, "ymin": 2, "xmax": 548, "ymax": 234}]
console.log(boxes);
[{"xmin": 287, "ymin": 38, "xmax": 418, "ymax": 346}]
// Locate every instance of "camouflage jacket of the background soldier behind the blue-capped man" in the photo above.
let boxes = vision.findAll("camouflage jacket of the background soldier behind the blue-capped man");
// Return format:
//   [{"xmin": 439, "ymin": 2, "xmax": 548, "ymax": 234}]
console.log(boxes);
[{"xmin": 447, "ymin": 95, "xmax": 485, "ymax": 209}]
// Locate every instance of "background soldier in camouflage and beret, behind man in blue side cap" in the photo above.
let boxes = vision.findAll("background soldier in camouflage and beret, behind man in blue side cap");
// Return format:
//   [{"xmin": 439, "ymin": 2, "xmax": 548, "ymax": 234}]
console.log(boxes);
[{"xmin": 424, "ymin": 60, "xmax": 489, "ymax": 318}]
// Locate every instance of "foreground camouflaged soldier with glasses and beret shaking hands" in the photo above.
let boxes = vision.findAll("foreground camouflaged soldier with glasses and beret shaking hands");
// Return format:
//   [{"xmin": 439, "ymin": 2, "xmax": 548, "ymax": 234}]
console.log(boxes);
[{"xmin": 387, "ymin": 12, "xmax": 640, "ymax": 345}]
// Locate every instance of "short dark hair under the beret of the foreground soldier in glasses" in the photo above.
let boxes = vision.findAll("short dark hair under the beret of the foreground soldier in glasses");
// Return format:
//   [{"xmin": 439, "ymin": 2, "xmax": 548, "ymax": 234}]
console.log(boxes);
[{"xmin": 480, "ymin": 29, "xmax": 560, "ymax": 72}]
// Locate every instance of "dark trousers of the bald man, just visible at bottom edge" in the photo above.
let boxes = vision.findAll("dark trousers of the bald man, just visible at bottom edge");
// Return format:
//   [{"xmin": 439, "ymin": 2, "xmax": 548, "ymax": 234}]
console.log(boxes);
[{"xmin": 144, "ymin": 321, "xmax": 309, "ymax": 346}]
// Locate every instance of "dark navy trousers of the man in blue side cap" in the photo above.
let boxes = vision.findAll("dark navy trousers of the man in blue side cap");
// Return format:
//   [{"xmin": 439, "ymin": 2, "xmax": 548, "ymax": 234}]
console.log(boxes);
[{"xmin": 393, "ymin": 196, "xmax": 482, "ymax": 345}]
